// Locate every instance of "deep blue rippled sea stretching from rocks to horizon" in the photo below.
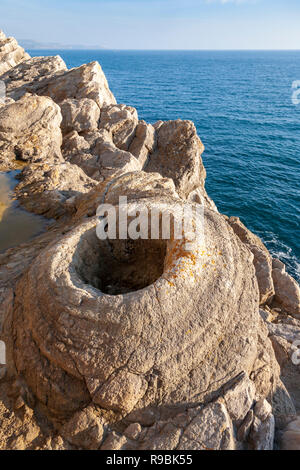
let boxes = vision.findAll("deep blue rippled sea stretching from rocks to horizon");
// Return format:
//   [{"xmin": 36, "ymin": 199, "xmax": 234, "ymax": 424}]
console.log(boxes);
[{"xmin": 31, "ymin": 50, "xmax": 300, "ymax": 280}]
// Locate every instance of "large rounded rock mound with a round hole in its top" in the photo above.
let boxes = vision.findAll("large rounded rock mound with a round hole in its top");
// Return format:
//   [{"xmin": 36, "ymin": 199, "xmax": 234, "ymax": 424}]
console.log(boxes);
[{"xmin": 13, "ymin": 174, "xmax": 260, "ymax": 413}]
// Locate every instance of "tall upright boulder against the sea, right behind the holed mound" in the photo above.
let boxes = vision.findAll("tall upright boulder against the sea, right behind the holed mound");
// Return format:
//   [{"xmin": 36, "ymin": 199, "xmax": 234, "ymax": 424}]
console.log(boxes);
[{"xmin": 146, "ymin": 120, "xmax": 206, "ymax": 198}]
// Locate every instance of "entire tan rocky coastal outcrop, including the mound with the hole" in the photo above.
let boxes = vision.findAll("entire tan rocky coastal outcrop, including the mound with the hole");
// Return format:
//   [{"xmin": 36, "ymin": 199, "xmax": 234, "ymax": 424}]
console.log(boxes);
[{"xmin": 0, "ymin": 30, "xmax": 300, "ymax": 451}]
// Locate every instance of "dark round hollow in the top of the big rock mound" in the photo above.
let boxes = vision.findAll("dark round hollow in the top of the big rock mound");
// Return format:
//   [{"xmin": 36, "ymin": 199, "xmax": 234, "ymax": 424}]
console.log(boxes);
[{"xmin": 73, "ymin": 228, "xmax": 167, "ymax": 295}]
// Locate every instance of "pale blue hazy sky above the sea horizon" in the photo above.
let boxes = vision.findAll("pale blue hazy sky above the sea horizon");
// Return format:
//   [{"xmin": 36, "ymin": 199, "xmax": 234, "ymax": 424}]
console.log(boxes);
[{"xmin": 0, "ymin": 0, "xmax": 300, "ymax": 49}]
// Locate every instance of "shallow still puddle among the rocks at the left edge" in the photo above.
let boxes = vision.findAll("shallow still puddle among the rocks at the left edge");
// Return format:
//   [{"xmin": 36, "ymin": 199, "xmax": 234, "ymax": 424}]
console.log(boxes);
[{"xmin": 0, "ymin": 171, "xmax": 47, "ymax": 252}]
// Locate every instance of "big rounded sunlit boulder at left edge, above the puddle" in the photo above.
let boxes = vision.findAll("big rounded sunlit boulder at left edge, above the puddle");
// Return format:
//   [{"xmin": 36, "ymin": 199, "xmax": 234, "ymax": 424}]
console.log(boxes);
[{"xmin": 0, "ymin": 95, "xmax": 63, "ymax": 169}]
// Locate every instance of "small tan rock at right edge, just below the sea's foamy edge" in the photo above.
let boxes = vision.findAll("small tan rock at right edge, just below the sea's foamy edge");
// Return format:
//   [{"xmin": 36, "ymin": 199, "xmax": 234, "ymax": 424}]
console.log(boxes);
[{"xmin": 272, "ymin": 263, "xmax": 300, "ymax": 318}]
